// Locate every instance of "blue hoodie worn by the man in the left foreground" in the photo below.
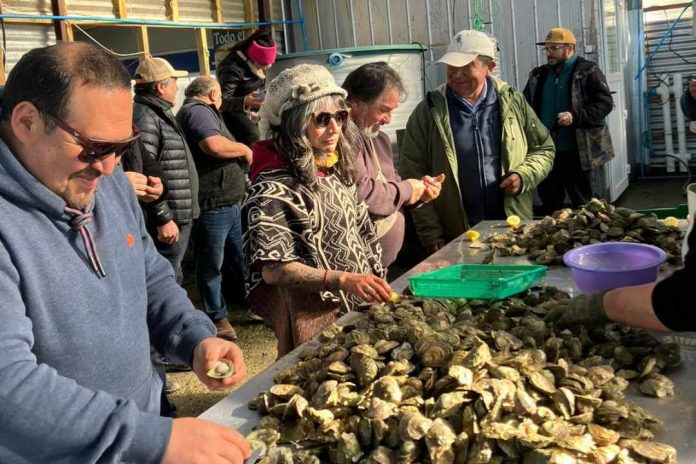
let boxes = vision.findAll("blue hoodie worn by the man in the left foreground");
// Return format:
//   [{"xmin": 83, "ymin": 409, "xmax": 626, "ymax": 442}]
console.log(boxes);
[{"xmin": 0, "ymin": 141, "xmax": 215, "ymax": 464}]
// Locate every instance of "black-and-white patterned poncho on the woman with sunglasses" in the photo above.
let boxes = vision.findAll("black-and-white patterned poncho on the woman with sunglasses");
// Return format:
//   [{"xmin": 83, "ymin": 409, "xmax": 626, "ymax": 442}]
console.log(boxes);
[{"xmin": 242, "ymin": 169, "xmax": 385, "ymax": 311}]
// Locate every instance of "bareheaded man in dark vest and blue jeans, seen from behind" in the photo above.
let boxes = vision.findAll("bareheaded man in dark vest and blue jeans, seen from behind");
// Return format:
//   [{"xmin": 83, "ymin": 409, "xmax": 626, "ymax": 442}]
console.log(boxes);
[{"xmin": 176, "ymin": 76, "xmax": 251, "ymax": 340}]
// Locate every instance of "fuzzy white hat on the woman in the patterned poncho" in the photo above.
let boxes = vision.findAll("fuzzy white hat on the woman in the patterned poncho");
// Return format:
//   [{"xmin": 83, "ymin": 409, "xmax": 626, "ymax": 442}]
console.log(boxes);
[{"xmin": 259, "ymin": 64, "xmax": 347, "ymax": 140}]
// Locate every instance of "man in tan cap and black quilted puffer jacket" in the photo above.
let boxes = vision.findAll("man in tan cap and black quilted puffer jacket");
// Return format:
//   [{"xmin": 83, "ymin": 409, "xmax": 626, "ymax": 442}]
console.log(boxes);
[{"xmin": 133, "ymin": 57, "xmax": 199, "ymax": 283}]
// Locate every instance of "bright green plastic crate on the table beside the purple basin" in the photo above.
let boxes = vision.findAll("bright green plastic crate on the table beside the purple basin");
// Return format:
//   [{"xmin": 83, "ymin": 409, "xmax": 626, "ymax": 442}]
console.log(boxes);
[{"xmin": 408, "ymin": 264, "xmax": 546, "ymax": 300}]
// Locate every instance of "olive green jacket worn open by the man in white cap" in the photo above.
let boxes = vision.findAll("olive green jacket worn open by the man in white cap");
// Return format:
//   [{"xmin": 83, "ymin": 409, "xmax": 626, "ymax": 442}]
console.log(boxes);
[{"xmin": 399, "ymin": 78, "xmax": 555, "ymax": 247}]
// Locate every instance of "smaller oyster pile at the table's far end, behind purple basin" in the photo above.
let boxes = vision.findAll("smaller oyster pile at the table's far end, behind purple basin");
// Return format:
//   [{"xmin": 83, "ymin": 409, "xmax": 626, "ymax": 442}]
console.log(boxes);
[{"xmin": 488, "ymin": 198, "xmax": 682, "ymax": 264}]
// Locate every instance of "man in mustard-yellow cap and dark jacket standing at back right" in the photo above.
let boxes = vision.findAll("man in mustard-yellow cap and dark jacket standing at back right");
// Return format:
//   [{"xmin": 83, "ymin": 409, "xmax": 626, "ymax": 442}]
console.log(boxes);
[{"xmin": 524, "ymin": 28, "xmax": 614, "ymax": 214}]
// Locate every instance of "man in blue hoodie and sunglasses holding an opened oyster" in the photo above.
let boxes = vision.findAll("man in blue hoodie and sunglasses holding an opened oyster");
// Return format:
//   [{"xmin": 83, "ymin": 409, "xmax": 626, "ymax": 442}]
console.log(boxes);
[{"xmin": 0, "ymin": 42, "xmax": 249, "ymax": 463}]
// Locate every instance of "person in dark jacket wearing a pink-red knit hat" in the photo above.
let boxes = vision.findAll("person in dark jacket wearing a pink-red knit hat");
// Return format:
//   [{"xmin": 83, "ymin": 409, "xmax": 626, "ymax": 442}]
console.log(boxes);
[{"xmin": 215, "ymin": 30, "xmax": 277, "ymax": 146}]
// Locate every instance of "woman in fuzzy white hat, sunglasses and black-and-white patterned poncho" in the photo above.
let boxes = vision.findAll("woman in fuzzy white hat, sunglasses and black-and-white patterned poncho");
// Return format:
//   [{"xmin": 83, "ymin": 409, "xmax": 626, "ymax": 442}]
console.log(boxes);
[{"xmin": 242, "ymin": 65, "xmax": 391, "ymax": 357}]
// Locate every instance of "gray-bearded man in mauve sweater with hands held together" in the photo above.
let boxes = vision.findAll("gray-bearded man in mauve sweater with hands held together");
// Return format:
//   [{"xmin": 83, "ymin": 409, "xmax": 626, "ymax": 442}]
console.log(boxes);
[{"xmin": 343, "ymin": 61, "xmax": 445, "ymax": 268}]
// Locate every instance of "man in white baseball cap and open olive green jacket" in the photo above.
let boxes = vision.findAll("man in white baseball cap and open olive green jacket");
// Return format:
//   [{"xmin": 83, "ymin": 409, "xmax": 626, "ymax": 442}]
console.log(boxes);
[{"xmin": 399, "ymin": 30, "xmax": 554, "ymax": 253}]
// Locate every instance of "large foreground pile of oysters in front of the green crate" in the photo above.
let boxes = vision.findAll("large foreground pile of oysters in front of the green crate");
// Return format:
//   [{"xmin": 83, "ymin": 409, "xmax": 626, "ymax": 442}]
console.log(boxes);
[{"xmin": 248, "ymin": 287, "xmax": 681, "ymax": 464}]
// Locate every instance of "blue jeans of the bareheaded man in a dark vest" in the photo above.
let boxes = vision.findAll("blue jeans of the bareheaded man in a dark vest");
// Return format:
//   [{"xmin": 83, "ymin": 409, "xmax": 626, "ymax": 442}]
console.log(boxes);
[{"xmin": 194, "ymin": 205, "xmax": 244, "ymax": 321}]
